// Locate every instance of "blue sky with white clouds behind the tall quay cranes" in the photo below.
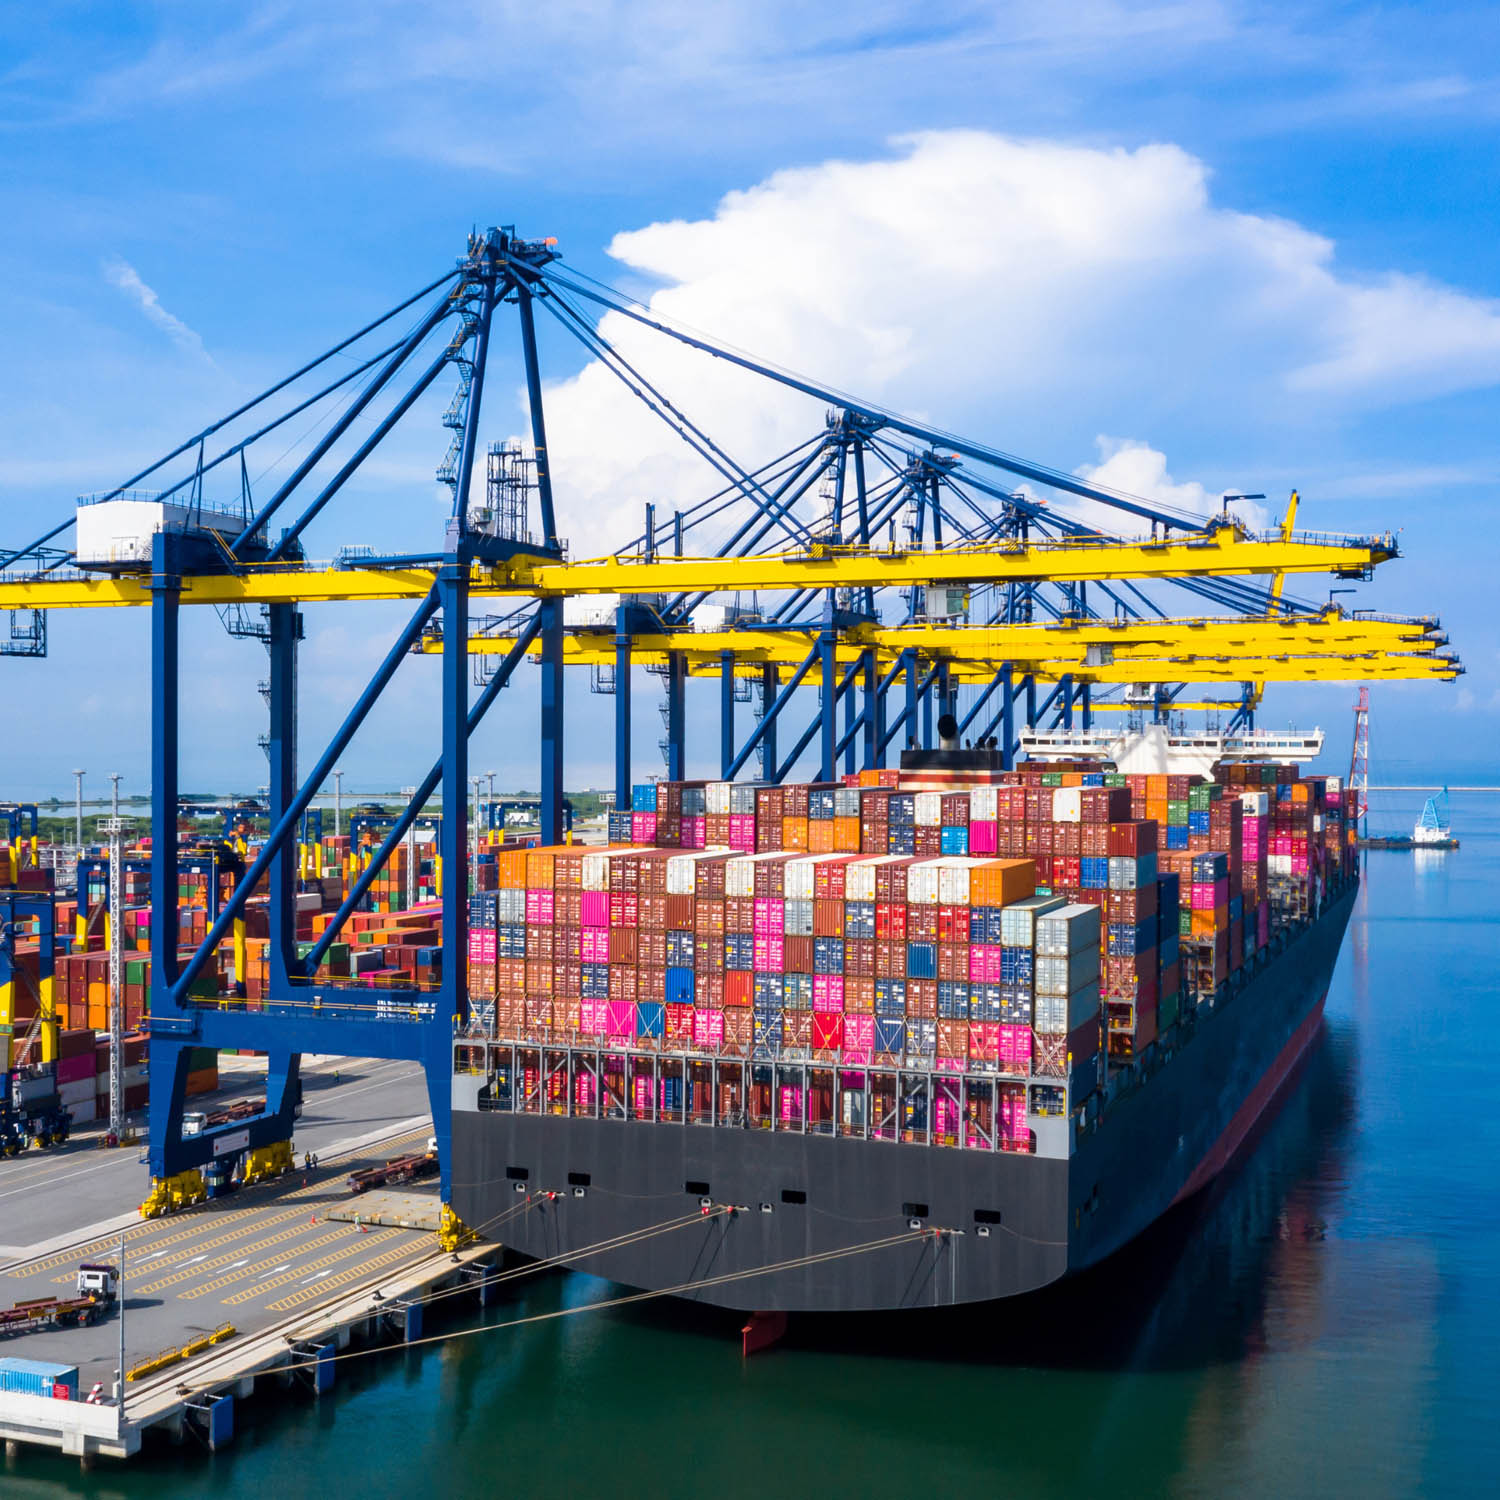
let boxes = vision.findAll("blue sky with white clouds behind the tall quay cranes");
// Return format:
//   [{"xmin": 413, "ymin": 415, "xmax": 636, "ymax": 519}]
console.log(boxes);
[{"xmin": 0, "ymin": 0, "xmax": 1500, "ymax": 797}]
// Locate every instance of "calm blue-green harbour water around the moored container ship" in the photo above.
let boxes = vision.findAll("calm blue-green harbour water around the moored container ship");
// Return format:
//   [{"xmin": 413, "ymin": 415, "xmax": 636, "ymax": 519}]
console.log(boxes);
[{"xmin": 0, "ymin": 795, "xmax": 1500, "ymax": 1500}]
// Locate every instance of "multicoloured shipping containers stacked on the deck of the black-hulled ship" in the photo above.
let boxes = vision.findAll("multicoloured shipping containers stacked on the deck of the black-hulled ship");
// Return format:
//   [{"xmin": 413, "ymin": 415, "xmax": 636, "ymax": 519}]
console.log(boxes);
[{"xmin": 470, "ymin": 764, "xmax": 1352, "ymax": 1151}]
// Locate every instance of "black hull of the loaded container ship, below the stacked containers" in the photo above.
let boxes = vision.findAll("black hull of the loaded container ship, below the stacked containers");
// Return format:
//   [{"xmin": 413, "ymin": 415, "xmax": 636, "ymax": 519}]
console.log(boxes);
[{"xmin": 453, "ymin": 888, "xmax": 1355, "ymax": 1313}]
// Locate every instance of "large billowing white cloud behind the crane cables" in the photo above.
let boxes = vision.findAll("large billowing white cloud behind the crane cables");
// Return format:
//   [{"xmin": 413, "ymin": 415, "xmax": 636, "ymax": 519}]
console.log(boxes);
[{"xmin": 531, "ymin": 131, "xmax": 1500, "ymax": 554}]
